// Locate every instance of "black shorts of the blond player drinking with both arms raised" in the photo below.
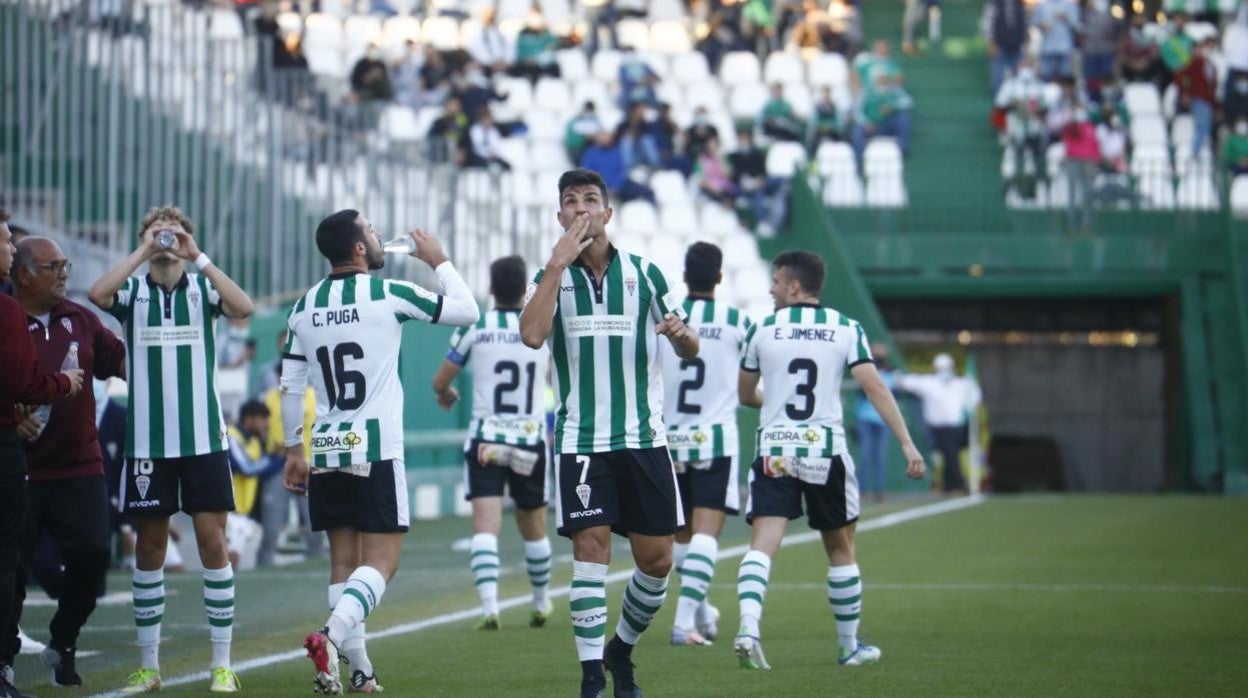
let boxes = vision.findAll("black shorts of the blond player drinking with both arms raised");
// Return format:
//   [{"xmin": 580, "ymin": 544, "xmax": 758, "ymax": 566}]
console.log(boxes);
[{"xmin": 117, "ymin": 451, "xmax": 235, "ymax": 517}]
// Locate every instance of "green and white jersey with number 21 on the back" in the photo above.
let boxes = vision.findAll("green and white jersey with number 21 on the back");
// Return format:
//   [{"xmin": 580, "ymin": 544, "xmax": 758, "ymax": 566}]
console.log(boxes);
[{"xmin": 447, "ymin": 310, "xmax": 550, "ymax": 446}]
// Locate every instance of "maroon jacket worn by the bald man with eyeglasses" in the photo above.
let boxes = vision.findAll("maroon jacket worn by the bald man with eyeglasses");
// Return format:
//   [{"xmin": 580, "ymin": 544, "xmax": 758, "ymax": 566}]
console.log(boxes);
[{"xmin": 26, "ymin": 294, "xmax": 126, "ymax": 482}]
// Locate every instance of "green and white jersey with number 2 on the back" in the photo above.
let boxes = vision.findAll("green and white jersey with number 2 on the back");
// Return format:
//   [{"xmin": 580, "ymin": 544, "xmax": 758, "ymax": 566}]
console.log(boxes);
[{"xmin": 659, "ymin": 298, "xmax": 754, "ymax": 462}]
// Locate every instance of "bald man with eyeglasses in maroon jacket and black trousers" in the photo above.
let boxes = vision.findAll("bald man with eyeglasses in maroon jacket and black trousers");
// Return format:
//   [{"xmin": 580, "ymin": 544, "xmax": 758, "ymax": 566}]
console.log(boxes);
[{"xmin": 4, "ymin": 237, "xmax": 126, "ymax": 686}]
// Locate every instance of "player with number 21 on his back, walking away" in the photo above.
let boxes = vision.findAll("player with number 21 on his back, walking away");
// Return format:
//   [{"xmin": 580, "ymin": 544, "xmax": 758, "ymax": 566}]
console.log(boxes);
[{"xmin": 433, "ymin": 256, "xmax": 550, "ymax": 631}]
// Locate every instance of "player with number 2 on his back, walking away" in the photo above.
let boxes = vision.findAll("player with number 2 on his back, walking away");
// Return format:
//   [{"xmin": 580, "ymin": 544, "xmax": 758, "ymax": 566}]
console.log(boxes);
[{"xmin": 659, "ymin": 242, "xmax": 751, "ymax": 646}]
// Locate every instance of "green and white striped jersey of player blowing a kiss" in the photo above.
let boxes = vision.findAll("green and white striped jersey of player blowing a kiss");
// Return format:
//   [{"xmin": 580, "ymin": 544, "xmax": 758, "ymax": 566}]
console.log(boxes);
[{"xmin": 530, "ymin": 246, "xmax": 685, "ymax": 453}]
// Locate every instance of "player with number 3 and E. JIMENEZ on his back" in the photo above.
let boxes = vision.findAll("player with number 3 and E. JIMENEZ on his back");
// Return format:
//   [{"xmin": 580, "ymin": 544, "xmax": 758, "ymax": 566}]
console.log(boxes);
[{"xmin": 733, "ymin": 251, "xmax": 925, "ymax": 669}]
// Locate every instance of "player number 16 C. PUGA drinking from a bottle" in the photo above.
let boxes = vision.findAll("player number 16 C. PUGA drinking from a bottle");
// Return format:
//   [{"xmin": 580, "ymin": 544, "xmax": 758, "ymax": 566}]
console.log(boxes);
[{"xmin": 281, "ymin": 209, "xmax": 479, "ymax": 694}]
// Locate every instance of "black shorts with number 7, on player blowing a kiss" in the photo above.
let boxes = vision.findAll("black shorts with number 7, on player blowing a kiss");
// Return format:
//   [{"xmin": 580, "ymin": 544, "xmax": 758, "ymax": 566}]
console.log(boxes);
[{"xmin": 555, "ymin": 446, "xmax": 685, "ymax": 537}]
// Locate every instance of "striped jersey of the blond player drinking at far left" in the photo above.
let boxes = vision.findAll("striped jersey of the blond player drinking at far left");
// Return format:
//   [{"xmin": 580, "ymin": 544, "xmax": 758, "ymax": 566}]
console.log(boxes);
[{"xmin": 109, "ymin": 272, "xmax": 226, "ymax": 458}]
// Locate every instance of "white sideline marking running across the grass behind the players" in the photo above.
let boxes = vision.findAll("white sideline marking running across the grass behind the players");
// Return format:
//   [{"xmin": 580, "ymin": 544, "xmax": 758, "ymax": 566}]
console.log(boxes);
[{"xmin": 91, "ymin": 494, "xmax": 986, "ymax": 698}]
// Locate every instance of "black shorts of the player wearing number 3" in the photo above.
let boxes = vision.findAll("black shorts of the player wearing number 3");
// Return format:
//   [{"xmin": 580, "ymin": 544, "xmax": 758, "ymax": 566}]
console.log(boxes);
[{"xmin": 745, "ymin": 453, "xmax": 859, "ymax": 531}]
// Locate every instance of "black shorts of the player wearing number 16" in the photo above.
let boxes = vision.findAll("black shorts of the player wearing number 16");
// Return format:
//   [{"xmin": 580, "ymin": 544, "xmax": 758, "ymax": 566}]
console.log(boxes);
[{"xmin": 308, "ymin": 460, "xmax": 411, "ymax": 533}]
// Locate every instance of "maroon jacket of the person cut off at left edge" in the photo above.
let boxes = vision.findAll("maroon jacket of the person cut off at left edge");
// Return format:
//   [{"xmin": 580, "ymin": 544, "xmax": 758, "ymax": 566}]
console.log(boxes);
[{"xmin": 0, "ymin": 293, "xmax": 70, "ymax": 426}]
